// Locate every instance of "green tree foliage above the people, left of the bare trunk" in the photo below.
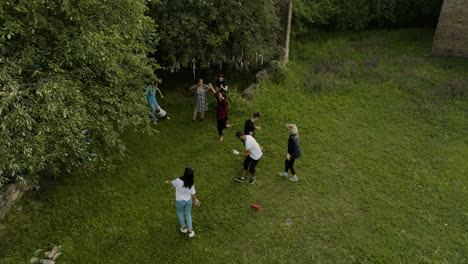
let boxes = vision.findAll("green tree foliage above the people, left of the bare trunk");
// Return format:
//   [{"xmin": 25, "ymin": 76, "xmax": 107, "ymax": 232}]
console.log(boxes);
[{"xmin": 148, "ymin": 0, "xmax": 279, "ymax": 69}]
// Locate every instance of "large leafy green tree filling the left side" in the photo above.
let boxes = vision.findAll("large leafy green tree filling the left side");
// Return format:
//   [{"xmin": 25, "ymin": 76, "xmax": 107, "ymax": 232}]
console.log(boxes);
[{"xmin": 0, "ymin": 0, "xmax": 156, "ymax": 184}]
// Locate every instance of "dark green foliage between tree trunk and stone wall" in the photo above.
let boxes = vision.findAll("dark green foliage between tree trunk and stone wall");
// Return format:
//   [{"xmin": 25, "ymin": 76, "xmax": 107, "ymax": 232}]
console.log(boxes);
[{"xmin": 293, "ymin": 0, "xmax": 442, "ymax": 33}]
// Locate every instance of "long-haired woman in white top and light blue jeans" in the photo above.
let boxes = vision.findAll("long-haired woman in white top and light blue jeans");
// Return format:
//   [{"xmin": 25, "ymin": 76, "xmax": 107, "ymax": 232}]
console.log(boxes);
[{"xmin": 166, "ymin": 167, "xmax": 200, "ymax": 237}]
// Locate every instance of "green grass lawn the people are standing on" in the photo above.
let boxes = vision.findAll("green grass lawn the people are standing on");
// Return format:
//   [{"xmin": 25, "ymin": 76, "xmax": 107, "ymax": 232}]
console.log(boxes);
[{"xmin": 0, "ymin": 29, "xmax": 468, "ymax": 264}]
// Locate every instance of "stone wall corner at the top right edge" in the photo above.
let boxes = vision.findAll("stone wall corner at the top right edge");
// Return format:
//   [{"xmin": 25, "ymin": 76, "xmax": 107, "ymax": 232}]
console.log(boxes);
[{"xmin": 432, "ymin": 0, "xmax": 468, "ymax": 57}]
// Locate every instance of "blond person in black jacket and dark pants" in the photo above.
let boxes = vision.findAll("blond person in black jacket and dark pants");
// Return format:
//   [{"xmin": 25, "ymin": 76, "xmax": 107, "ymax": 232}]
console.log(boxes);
[{"xmin": 279, "ymin": 124, "xmax": 301, "ymax": 182}]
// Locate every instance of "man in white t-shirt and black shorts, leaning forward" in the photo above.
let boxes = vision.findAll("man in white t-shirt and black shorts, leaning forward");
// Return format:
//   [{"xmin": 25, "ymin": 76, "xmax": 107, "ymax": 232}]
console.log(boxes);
[{"xmin": 232, "ymin": 131, "xmax": 264, "ymax": 184}]
